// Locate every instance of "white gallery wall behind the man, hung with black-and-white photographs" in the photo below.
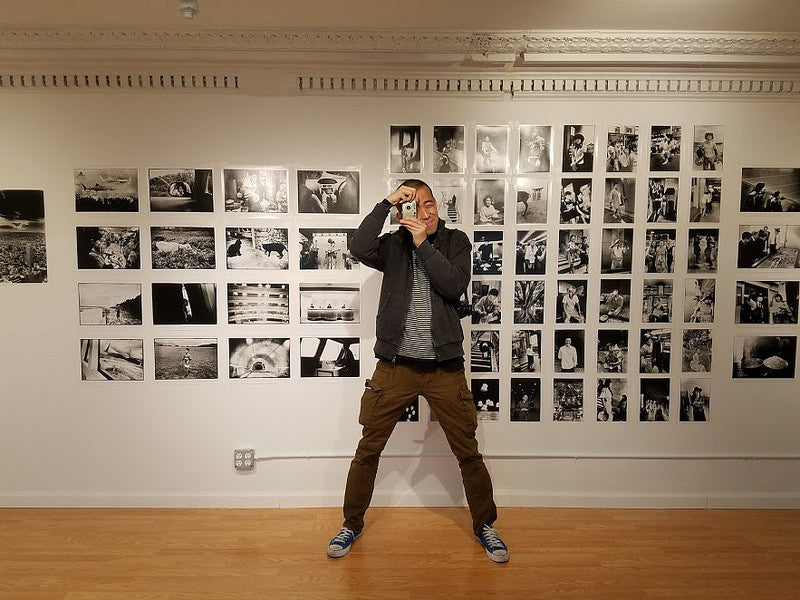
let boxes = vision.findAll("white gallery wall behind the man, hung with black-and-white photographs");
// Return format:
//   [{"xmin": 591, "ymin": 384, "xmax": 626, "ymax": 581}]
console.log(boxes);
[{"xmin": 0, "ymin": 91, "xmax": 800, "ymax": 507}]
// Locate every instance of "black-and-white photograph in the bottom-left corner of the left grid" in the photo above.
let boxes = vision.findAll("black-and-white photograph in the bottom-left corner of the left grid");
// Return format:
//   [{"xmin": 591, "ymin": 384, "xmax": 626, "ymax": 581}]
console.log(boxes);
[{"xmin": 81, "ymin": 339, "xmax": 144, "ymax": 381}]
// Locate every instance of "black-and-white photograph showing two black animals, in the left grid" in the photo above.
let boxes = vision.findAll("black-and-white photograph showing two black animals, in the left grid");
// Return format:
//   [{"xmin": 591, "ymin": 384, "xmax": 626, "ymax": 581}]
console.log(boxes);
[{"xmin": 225, "ymin": 227, "xmax": 289, "ymax": 270}]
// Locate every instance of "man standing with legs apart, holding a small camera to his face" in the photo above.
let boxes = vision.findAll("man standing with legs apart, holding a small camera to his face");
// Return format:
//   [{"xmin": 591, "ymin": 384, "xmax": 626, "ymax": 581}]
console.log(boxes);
[{"xmin": 328, "ymin": 179, "xmax": 509, "ymax": 562}]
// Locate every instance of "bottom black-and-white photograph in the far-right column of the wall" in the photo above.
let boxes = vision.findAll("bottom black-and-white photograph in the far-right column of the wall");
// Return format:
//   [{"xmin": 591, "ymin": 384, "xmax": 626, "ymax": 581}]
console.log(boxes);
[{"xmin": 733, "ymin": 335, "xmax": 797, "ymax": 379}]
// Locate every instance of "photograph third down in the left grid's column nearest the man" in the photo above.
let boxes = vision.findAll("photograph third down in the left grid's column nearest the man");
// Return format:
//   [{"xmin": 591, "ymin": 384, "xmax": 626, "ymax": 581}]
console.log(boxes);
[{"xmin": 300, "ymin": 283, "xmax": 361, "ymax": 324}]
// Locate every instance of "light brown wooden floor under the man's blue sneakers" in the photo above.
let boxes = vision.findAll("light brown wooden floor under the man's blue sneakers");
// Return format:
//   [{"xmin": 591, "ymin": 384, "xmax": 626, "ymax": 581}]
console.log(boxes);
[{"xmin": 0, "ymin": 508, "xmax": 800, "ymax": 600}]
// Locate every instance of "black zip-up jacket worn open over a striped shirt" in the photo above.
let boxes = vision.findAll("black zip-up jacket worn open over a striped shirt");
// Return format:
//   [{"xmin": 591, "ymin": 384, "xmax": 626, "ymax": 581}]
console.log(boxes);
[{"xmin": 350, "ymin": 202, "xmax": 472, "ymax": 362}]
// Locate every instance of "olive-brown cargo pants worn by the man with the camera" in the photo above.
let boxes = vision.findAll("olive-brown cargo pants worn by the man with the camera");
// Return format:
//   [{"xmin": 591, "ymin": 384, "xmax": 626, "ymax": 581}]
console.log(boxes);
[{"xmin": 344, "ymin": 360, "xmax": 497, "ymax": 534}]
